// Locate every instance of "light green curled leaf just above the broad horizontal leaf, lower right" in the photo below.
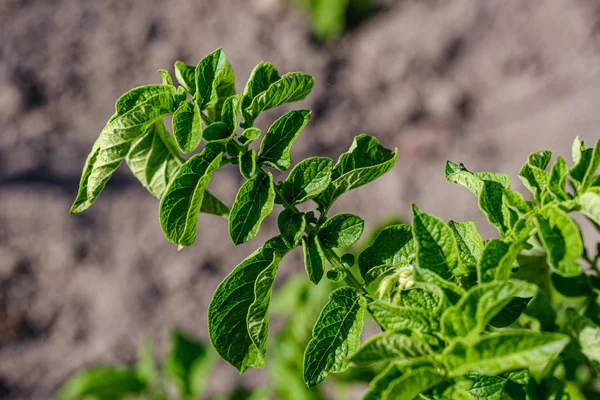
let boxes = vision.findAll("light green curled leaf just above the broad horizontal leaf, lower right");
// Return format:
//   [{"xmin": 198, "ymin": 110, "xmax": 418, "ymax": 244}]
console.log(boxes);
[{"xmin": 441, "ymin": 280, "xmax": 536, "ymax": 337}]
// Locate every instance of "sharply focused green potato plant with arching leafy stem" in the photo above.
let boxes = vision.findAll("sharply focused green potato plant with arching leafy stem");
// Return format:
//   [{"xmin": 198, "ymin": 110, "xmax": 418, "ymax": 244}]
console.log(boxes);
[{"xmin": 71, "ymin": 49, "xmax": 600, "ymax": 400}]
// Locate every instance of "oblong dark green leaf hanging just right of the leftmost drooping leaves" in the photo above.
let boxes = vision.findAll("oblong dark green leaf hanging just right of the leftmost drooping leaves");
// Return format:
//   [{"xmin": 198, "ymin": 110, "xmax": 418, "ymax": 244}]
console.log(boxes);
[{"xmin": 159, "ymin": 143, "xmax": 225, "ymax": 246}]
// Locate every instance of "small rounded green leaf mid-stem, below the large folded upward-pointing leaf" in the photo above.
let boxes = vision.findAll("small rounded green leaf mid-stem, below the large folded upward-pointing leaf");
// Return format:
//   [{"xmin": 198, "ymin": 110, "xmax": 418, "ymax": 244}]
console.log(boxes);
[{"xmin": 318, "ymin": 214, "xmax": 365, "ymax": 249}]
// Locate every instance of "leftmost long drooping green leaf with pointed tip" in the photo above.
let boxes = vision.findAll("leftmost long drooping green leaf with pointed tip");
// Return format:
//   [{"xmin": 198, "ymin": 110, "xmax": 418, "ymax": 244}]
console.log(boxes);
[{"xmin": 71, "ymin": 85, "xmax": 175, "ymax": 213}]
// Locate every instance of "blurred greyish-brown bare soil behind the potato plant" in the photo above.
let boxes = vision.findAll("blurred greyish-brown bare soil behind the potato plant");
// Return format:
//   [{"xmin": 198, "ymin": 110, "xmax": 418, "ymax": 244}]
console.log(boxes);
[{"xmin": 0, "ymin": 0, "xmax": 600, "ymax": 399}]
